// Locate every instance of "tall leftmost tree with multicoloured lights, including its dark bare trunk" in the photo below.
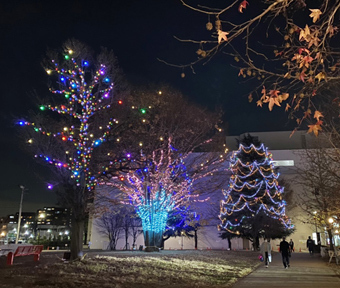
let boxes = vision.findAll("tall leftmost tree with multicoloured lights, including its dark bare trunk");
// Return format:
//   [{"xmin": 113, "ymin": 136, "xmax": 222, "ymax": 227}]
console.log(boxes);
[{"xmin": 18, "ymin": 40, "xmax": 129, "ymax": 259}]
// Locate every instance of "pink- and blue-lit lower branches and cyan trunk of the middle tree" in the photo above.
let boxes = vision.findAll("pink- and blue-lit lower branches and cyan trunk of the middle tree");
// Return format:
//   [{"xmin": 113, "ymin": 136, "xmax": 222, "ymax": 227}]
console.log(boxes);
[{"xmin": 105, "ymin": 139, "xmax": 222, "ymax": 251}]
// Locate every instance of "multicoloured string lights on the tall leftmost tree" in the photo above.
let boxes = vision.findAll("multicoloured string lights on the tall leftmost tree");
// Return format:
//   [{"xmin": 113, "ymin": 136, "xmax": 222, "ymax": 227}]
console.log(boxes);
[{"xmin": 18, "ymin": 49, "xmax": 121, "ymax": 190}]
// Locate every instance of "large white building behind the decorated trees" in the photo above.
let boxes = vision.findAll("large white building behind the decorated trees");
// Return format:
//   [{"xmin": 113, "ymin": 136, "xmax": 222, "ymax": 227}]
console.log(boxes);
[{"xmin": 88, "ymin": 131, "xmax": 338, "ymax": 251}]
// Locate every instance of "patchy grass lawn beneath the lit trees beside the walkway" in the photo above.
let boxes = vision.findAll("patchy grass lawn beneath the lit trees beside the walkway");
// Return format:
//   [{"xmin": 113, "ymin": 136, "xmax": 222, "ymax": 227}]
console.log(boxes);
[{"xmin": 0, "ymin": 250, "xmax": 259, "ymax": 288}]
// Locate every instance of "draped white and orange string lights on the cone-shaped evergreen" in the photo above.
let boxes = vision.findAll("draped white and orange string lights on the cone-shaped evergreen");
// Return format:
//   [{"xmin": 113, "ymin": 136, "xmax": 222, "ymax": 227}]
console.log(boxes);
[{"xmin": 219, "ymin": 144, "xmax": 293, "ymax": 234}]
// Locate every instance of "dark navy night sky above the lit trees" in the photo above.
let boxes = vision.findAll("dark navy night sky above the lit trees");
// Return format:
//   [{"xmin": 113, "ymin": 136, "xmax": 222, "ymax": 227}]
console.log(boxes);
[{"xmin": 0, "ymin": 0, "xmax": 290, "ymax": 216}]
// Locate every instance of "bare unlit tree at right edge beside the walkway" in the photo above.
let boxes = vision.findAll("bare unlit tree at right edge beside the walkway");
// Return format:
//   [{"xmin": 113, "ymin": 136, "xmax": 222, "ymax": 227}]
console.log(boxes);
[{"xmin": 295, "ymin": 147, "xmax": 340, "ymax": 249}]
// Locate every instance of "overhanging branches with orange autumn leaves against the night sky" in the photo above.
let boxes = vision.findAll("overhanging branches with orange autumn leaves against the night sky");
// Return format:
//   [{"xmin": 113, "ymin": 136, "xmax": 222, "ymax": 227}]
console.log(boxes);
[{"xmin": 163, "ymin": 0, "xmax": 340, "ymax": 135}]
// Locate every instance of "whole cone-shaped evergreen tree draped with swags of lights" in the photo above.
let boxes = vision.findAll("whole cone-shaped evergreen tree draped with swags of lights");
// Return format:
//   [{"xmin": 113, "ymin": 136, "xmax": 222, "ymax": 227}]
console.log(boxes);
[{"xmin": 219, "ymin": 135, "xmax": 293, "ymax": 249}]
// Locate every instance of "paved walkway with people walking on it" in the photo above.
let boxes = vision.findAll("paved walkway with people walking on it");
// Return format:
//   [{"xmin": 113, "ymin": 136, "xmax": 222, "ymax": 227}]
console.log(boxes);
[{"xmin": 232, "ymin": 252, "xmax": 340, "ymax": 288}]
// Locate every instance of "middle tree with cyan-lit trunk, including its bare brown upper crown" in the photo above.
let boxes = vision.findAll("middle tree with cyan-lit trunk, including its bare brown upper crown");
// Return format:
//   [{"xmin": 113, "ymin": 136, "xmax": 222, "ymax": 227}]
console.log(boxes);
[{"xmin": 99, "ymin": 88, "xmax": 224, "ymax": 251}]
